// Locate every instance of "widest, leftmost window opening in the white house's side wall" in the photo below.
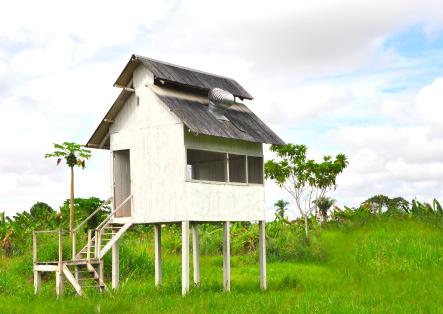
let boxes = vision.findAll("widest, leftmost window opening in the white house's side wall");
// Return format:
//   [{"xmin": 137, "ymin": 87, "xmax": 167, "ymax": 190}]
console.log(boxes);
[{"xmin": 186, "ymin": 149, "xmax": 226, "ymax": 182}]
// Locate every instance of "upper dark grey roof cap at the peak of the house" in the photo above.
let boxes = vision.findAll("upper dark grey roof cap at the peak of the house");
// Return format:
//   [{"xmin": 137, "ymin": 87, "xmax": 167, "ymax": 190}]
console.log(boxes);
[{"xmin": 115, "ymin": 55, "xmax": 253, "ymax": 99}]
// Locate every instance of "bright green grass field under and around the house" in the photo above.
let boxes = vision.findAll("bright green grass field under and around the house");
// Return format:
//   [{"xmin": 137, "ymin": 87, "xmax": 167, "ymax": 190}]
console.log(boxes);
[{"xmin": 0, "ymin": 218, "xmax": 443, "ymax": 313}]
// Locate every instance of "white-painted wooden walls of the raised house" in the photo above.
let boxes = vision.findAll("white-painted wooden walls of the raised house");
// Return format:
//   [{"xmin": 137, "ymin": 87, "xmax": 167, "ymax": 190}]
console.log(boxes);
[{"xmin": 110, "ymin": 66, "xmax": 265, "ymax": 223}]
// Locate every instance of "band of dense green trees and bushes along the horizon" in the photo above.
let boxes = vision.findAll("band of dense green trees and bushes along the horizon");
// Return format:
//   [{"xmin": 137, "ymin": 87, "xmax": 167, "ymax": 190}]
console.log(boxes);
[{"xmin": 0, "ymin": 195, "xmax": 443, "ymax": 259}]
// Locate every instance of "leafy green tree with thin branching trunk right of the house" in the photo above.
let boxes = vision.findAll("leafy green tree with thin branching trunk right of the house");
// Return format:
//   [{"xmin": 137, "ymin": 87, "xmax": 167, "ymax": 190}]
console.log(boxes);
[{"xmin": 265, "ymin": 144, "xmax": 348, "ymax": 237}]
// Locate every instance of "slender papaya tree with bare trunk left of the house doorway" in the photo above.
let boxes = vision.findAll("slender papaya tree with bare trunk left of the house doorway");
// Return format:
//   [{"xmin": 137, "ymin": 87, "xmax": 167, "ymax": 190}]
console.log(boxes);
[{"xmin": 45, "ymin": 142, "xmax": 91, "ymax": 234}]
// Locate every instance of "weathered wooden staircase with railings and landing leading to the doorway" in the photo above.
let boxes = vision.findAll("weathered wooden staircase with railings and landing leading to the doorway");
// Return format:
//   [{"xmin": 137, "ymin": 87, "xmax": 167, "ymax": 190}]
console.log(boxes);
[{"xmin": 33, "ymin": 195, "xmax": 132, "ymax": 295}]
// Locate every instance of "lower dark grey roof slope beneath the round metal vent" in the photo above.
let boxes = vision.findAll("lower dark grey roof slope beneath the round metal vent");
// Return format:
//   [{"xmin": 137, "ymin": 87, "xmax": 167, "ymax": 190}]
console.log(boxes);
[{"xmin": 158, "ymin": 95, "xmax": 285, "ymax": 145}]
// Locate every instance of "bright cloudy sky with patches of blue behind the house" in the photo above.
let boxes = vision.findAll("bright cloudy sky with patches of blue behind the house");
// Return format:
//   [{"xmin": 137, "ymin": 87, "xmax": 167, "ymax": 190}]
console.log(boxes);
[{"xmin": 0, "ymin": 0, "xmax": 443, "ymax": 218}]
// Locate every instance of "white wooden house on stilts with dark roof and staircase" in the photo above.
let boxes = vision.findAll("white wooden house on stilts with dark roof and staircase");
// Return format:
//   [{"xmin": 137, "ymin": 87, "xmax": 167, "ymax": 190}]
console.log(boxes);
[{"xmin": 34, "ymin": 55, "xmax": 284, "ymax": 295}]
